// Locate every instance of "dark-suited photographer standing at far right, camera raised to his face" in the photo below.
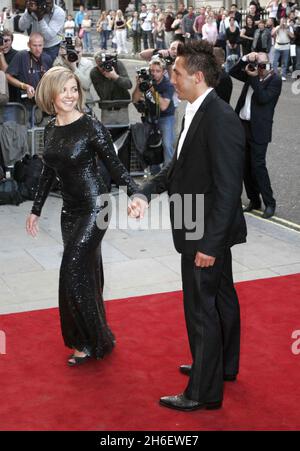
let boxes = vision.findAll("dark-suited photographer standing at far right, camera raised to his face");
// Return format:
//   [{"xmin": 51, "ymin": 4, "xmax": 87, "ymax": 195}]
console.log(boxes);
[{"xmin": 229, "ymin": 52, "xmax": 282, "ymax": 218}]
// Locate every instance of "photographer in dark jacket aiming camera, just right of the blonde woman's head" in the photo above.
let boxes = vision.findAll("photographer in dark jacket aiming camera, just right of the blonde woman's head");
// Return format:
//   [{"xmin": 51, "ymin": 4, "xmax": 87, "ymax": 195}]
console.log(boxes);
[{"xmin": 90, "ymin": 52, "xmax": 132, "ymax": 124}]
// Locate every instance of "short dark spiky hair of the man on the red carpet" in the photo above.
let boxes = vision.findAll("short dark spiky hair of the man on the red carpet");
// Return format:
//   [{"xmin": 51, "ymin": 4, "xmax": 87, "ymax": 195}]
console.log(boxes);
[{"xmin": 177, "ymin": 40, "xmax": 220, "ymax": 88}]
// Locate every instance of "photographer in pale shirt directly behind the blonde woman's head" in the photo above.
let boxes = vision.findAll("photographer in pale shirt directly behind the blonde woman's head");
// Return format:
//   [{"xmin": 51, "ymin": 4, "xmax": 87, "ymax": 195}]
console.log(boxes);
[{"xmin": 53, "ymin": 37, "xmax": 94, "ymax": 103}]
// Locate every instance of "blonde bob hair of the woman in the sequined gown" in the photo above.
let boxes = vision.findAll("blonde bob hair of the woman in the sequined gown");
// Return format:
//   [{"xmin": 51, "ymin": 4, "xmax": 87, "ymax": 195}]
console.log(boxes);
[{"xmin": 35, "ymin": 66, "xmax": 84, "ymax": 115}]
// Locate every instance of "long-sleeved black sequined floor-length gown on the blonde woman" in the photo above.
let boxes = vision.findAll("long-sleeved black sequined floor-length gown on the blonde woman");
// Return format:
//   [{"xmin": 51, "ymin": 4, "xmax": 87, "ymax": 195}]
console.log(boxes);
[{"xmin": 32, "ymin": 115, "xmax": 138, "ymax": 358}]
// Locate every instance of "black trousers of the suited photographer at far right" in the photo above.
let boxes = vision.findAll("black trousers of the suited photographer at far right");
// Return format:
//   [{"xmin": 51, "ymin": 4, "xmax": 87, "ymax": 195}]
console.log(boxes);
[{"xmin": 242, "ymin": 121, "xmax": 276, "ymax": 207}]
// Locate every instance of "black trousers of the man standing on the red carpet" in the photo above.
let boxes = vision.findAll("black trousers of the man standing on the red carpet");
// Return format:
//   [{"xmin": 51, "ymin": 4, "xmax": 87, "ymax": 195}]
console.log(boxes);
[{"xmin": 181, "ymin": 248, "xmax": 240, "ymax": 402}]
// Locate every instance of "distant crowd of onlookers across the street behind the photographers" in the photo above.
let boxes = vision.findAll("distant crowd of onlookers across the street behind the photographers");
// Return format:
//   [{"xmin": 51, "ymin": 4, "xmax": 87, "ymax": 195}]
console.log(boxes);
[{"xmin": 0, "ymin": 0, "xmax": 300, "ymax": 71}]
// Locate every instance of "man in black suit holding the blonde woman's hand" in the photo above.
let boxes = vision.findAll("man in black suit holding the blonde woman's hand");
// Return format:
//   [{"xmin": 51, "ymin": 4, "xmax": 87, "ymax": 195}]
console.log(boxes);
[{"xmin": 130, "ymin": 41, "xmax": 246, "ymax": 411}]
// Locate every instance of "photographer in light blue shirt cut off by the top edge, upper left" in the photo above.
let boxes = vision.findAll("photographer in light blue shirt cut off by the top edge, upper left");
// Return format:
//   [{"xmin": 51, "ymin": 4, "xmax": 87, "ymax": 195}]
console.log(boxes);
[{"xmin": 19, "ymin": 0, "xmax": 66, "ymax": 62}]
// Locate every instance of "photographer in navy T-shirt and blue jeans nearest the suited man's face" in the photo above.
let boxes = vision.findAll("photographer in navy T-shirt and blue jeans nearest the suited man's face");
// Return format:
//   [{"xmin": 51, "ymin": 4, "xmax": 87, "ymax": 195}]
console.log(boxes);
[{"xmin": 132, "ymin": 58, "xmax": 175, "ymax": 173}]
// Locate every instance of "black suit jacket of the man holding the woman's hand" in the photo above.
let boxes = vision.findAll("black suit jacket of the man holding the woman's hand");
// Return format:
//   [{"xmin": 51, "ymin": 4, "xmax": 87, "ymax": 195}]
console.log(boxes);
[{"xmin": 142, "ymin": 91, "xmax": 246, "ymax": 256}]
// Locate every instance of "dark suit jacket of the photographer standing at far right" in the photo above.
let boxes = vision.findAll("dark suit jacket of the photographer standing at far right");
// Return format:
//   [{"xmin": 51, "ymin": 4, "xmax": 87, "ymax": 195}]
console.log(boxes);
[{"xmin": 229, "ymin": 59, "xmax": 282, "ymax": 144}]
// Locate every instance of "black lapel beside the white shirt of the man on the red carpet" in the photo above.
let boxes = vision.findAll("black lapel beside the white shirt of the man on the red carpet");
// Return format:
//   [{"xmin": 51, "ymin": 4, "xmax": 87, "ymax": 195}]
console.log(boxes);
[{"xmin": 169, "ymin": 90, "xmax": 217, "ymax": 182}]
